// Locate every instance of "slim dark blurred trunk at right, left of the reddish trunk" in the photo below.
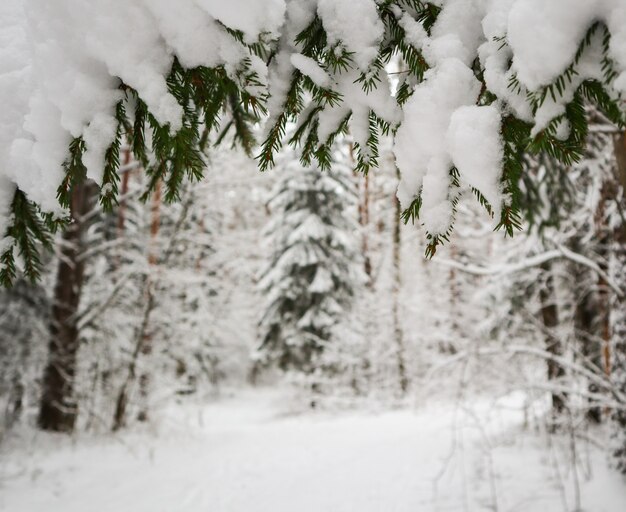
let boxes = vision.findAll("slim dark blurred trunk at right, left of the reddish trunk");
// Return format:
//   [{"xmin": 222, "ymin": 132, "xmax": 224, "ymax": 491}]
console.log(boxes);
[{"xmin": 539, "ymin": 263, "xmax": 565, "ymax": 418}]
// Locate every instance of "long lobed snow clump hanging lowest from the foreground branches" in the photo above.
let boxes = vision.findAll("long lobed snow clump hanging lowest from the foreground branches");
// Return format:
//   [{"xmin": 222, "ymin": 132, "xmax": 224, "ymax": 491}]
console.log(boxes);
[{"xmin": 394, "ymin": 0, "xmax": 502, "ymax": 235}]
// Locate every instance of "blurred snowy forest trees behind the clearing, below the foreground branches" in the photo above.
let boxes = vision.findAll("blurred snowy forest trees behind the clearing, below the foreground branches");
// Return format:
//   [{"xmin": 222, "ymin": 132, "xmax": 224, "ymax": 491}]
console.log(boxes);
[{"xmin": 0, "ymin": 127, "xmax": 626, "ymax": 469}]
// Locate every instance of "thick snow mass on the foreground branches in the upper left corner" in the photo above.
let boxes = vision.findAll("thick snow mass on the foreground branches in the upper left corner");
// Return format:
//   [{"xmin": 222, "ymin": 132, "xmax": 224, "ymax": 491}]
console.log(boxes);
[{"xmin": 0, "ymin": 0, "xmax": 285, "ymax": 216}]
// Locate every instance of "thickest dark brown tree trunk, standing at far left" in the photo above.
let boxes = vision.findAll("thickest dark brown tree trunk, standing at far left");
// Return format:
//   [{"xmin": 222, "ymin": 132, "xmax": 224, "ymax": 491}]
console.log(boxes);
[{"xmin": 38, "ymin": 181, "xmax": 93, "ymax": 432}]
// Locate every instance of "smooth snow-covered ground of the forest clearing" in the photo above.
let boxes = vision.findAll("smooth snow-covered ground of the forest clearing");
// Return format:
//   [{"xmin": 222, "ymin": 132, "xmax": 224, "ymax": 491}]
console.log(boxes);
[{"xmin": 0, "ymin": 392, "xmax": 626, "ymax": 512}]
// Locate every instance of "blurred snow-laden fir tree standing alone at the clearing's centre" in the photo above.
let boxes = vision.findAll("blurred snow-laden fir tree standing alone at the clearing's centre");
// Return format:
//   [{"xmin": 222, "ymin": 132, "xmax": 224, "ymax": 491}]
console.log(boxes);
[{"xmin": 258, "ymin": 146, "xmax": 362, "ymax": 373}]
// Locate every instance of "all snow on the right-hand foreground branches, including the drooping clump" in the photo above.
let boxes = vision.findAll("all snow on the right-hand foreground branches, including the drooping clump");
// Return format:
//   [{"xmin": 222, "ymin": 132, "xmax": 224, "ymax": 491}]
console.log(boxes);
[{"xmin": 394, "ymin": 0, "xmax": 626, "ymax": 235}]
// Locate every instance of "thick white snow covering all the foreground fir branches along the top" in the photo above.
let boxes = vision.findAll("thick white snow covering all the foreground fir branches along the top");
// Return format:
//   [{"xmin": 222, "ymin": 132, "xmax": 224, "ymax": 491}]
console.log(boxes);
[{"xmin": 0, "ymin": 0, "xmax": 626, "ymax": 232}]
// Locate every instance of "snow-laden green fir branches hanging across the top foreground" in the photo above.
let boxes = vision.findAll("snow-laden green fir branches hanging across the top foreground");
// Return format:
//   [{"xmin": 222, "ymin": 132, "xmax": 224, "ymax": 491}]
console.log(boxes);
[{"xmin": 0, "ymin": 0, "xmax": 626, "ymax": 285}]
